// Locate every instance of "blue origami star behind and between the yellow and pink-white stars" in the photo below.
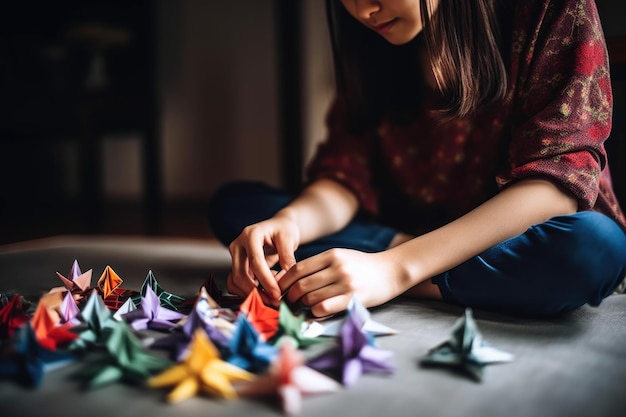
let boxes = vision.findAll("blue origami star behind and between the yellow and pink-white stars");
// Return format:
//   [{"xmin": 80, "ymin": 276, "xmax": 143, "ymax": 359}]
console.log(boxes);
[{"xmin": 225, "ymin": 315, "xmax": 278, "ymax": 373}]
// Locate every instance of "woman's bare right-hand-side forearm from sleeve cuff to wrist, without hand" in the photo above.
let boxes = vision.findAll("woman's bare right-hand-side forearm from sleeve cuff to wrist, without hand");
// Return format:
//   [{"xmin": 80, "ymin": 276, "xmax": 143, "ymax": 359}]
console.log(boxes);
[{"xmin": 385, "ymin": 179, "xmax": 577, "ymax": 292}]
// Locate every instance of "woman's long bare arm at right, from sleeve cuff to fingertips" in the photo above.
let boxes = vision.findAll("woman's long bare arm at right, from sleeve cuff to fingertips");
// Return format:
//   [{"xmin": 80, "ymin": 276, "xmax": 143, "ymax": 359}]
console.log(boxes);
[{"xmin": 279, "ymin": 179, "xmax": 577, "ymax": 317}]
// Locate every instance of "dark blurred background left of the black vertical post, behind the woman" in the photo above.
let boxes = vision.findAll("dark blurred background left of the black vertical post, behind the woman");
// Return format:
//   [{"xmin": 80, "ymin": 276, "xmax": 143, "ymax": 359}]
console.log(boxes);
[{"xmin": 0, "ymin": 0, "xmax": 288, "ymax": 242}]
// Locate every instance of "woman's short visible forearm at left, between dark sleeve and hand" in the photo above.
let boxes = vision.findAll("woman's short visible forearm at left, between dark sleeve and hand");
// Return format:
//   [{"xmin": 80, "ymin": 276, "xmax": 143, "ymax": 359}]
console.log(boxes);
[{"xmin": 274, "ymin": 179, "xmax": 358, "ymax": 244}]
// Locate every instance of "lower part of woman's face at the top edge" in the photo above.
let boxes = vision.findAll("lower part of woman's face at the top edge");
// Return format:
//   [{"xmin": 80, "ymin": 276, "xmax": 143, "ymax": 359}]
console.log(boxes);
[{"xmin": 341, "ymin": 0, "xmax": 439, "ymax": 45}]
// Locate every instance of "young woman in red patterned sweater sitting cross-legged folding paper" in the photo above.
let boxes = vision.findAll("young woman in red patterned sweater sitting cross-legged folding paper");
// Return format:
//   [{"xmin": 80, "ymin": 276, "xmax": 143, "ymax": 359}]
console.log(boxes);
[{"xmin": 209, "ymin": 0, "xmax": 626, "ymax": 317}]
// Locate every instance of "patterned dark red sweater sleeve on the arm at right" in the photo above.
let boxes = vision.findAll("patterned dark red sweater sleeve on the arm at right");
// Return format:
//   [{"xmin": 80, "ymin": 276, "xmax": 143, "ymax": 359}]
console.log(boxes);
[{"xmin": 498, "ymin": 0, "xmax": 612, "ymax": 210}]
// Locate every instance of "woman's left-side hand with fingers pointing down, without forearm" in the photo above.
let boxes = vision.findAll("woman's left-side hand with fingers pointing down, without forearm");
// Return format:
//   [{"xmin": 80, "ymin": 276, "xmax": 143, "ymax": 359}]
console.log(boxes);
[{"xmin": 227, "ymin": 216, "xmax": 300, "ymax": 306}]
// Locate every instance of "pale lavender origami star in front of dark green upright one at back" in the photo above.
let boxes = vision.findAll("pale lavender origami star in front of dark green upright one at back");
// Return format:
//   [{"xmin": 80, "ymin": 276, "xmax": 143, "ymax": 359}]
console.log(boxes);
[{"xmin": 124, "ymin": 287, "xmax": 185, "ymax": 330}]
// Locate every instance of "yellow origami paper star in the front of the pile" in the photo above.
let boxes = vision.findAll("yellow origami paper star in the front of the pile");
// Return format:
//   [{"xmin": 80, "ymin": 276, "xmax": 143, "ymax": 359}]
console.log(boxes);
[{"xmin": 147, "ymin": 329, "xmax": 254, "ymax": 403}]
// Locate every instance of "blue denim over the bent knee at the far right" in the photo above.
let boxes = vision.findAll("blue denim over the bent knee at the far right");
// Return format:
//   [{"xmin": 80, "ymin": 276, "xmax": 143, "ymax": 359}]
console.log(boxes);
[{"xmin": 432, "ymin": 211, "xmax": 626, "ymax": 315}]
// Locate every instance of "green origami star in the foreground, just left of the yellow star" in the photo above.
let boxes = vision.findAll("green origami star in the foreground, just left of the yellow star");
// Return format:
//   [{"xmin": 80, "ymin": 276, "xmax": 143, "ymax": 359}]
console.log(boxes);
[{"xmin": 74, "ymin": 322, "xmax": 172, "ymax": 388}]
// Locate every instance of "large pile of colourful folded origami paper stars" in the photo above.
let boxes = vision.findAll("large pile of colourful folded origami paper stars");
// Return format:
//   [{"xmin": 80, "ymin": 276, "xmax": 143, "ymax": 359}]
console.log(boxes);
[{"xmin": 0, "ymin": 261, "xmax": 394, "ymax": 414}]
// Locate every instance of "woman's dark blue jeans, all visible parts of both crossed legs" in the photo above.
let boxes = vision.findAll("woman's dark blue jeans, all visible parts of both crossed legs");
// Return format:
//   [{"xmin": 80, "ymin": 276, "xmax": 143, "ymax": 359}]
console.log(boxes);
[{"xmin": 209, "ymin": 181, "xmax": 626, "ymax": 315}]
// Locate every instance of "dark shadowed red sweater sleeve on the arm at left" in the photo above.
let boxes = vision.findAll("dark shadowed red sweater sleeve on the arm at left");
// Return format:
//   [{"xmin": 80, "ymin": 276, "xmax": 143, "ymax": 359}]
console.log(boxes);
[{"xmin": 306, "ymin": 97, "xmax": 379, "ymax": 215}]
